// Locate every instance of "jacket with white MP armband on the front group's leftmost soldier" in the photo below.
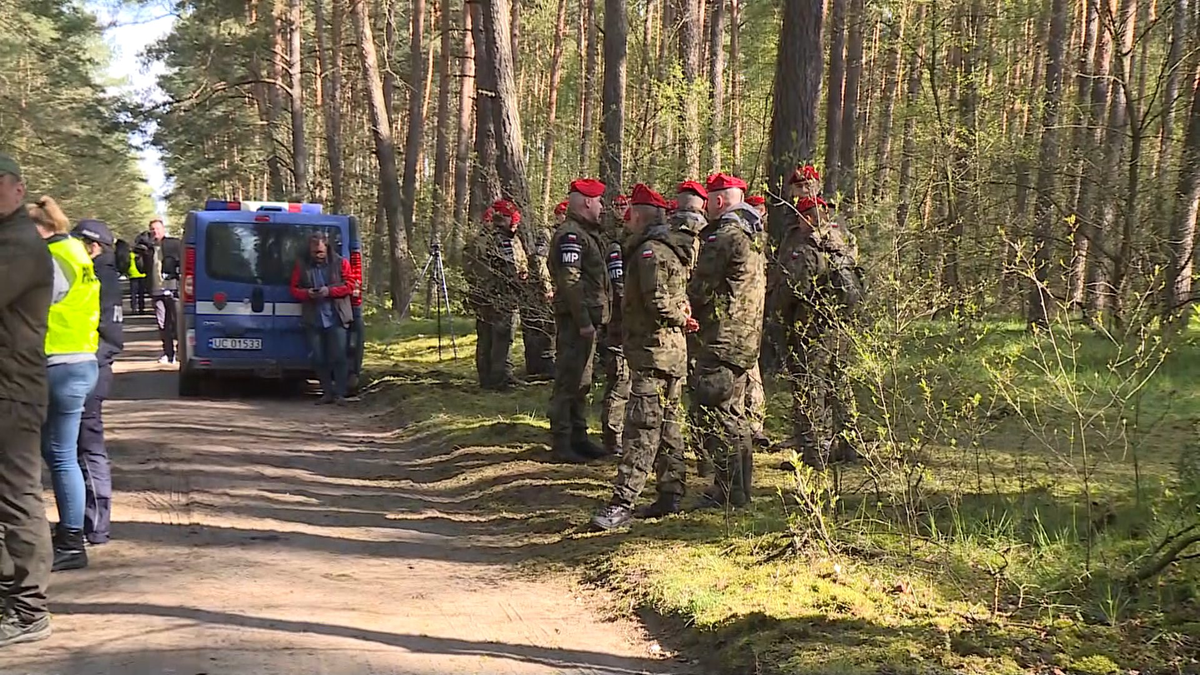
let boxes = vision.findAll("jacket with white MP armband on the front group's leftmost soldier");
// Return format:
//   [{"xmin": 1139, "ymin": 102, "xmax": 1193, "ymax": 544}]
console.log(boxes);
[{"xmin": 548, "ymin": 216, "xmax": 612, "ymax": 327}]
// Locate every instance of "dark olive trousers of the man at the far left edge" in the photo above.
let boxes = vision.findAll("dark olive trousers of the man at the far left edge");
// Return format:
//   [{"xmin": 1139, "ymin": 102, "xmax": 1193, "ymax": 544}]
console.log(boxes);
[{"xmin": 0, "ymin": 399, "xmax": 54, "ymax": 622}]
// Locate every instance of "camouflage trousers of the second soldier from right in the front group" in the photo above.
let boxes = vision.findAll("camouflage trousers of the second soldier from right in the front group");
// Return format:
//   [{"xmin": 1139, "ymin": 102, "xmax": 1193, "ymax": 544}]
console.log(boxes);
[{"xmin": 692, "ymin": 362, "xmax": 754, "ymax": 503}]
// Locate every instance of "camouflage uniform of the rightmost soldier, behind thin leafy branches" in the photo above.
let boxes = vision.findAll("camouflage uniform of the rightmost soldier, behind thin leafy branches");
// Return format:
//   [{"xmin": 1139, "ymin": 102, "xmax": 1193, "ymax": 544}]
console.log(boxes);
[{"xmin": 768, "ymin": 207, "xmax": 862, "ymax": 468}]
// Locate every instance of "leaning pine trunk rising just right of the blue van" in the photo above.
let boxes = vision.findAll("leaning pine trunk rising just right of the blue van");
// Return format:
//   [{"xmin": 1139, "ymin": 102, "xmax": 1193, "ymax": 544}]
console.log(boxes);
[{"xmin": 350, "ymin": 0, "xmax": 413, "ymax": 312}]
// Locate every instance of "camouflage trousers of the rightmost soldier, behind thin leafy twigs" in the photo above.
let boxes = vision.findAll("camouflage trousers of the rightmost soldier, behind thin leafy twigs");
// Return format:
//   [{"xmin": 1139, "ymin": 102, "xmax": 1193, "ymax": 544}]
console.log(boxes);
[{"xmin": 785, "ymin": 328, "xmax": 857, "ymax": 468}]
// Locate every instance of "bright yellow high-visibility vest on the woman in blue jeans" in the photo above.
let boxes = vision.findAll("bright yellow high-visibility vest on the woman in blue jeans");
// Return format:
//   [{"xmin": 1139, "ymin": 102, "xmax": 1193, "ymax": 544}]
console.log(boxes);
[{"xmin": 46, "ymin": 237, "xmax": 100, "ymax": 356}]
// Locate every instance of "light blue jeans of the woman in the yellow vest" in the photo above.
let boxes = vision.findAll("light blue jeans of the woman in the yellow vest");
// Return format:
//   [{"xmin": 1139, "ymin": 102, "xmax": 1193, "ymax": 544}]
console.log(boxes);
[{"xmin": 42, "ymin": 360, "xmax": 100, "ymax": 530}]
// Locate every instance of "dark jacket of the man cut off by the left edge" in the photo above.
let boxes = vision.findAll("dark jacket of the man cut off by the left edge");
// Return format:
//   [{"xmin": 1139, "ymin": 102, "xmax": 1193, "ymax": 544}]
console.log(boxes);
[{"xmin": 0, "ymin": 207, "xmax": 54, "ymax": 403}]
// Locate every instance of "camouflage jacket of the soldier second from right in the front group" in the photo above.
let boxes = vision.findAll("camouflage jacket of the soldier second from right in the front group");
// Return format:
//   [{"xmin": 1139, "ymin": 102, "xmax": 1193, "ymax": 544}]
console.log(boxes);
[{"xmin": 688, "ymin": 204, "xmax": 767, "ymax": 369}]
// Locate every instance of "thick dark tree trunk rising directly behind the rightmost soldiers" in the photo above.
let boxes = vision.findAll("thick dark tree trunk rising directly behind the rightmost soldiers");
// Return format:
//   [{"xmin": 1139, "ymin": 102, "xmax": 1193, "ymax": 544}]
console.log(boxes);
[{"xmin": 768, "ymin": 0, "xmax": 824, "ymax": 241}]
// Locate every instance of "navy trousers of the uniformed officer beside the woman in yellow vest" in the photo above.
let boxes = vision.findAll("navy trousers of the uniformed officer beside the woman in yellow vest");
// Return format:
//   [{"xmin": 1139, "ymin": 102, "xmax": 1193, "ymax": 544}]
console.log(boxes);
[{"xmin": 79, "ymin": 364, "xmax": 113, "ymax": 544}]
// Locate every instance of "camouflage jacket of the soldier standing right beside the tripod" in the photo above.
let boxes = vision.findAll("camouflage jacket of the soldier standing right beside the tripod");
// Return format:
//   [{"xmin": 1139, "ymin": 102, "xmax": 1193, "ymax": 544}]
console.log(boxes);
[{"xmin": 463, "ymin": 227, "xmax": 529, "ymax": 311}]
